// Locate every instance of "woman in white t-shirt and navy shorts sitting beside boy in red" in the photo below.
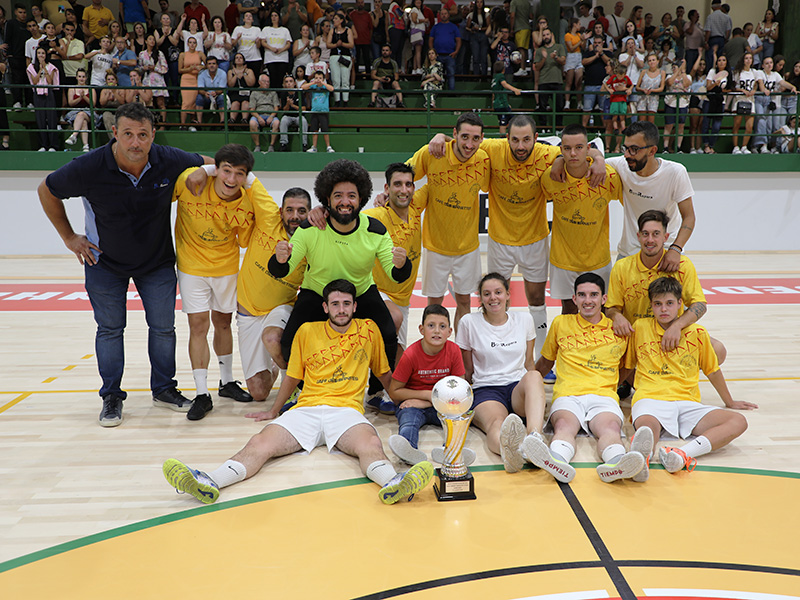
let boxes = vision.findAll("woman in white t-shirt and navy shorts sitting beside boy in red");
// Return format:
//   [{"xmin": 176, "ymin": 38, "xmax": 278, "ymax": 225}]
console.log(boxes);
[{"xmin": 456, "ymin": 273, "xmax": 545, "ymax": 473}]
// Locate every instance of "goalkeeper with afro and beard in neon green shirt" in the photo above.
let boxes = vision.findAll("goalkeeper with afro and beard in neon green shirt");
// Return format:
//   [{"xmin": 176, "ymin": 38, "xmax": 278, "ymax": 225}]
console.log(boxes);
[{"xmin": 268, "ymin": 159, "xmax": 412, "ymax": 365}]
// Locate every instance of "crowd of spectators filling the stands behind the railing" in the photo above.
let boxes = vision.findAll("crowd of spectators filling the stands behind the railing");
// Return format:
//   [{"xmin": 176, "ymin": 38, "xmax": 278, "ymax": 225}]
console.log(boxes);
[{"xmin": 0, "ymin": 0, "xmax": 800, "ymax": 154}]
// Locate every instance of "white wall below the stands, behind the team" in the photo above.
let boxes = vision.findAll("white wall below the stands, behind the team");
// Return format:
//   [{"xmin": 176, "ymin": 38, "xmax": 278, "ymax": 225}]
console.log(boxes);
[{"xmin": 9, "ymin": 171, "xmax": 800, "ymax": 255}]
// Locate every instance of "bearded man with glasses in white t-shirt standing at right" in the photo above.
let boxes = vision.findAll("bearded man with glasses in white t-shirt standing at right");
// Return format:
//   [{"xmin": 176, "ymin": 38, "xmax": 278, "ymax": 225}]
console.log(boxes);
[{"xmin": 608, "ymin": 121, "xmax": 695, "ymax": 272}]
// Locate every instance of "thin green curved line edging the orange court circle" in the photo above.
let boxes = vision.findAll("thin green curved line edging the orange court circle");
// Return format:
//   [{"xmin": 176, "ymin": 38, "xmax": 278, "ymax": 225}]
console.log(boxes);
[{"xmin": 0, "ymin": 462, "xmax": 800, "ymax": 573}]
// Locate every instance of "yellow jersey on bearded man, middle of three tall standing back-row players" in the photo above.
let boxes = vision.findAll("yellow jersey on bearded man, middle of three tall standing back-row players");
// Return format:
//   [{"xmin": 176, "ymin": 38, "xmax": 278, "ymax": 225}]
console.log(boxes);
[{"xmin": 481, "ymin": 139, "xmax": 561, "ymax": 246}]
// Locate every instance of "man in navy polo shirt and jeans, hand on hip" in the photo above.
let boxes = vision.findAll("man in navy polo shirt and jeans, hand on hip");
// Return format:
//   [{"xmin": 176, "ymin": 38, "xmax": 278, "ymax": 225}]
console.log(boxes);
[{"xmin": 38, "ymin": 104, "xmax": 212, "ymax": 427}]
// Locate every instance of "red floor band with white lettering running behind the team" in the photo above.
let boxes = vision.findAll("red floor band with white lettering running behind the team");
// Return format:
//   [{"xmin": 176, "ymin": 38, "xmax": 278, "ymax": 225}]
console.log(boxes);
[{"xmin": 0, "ymin": 277, "xmax": 800, "ymax": 312}]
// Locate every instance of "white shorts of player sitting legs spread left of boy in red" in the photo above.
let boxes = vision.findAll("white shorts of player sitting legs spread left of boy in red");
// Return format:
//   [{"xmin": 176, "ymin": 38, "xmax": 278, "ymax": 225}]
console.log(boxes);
[{"xmin": 267, "ymin": 406, "xmax": 378, "ymax": 452}]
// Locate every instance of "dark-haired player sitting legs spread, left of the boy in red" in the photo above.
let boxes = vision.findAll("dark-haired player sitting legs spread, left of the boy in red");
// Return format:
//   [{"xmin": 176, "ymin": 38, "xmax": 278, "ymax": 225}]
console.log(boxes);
[{"xmin": 162, "ymin": 278, "xmax": 433, "ymax": 504}]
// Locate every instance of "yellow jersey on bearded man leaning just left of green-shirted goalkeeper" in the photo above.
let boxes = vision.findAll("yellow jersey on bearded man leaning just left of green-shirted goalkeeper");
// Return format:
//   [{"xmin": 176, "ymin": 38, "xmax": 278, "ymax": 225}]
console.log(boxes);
[{"xmin": 236, "ymin": 179, "xmax": 306, "ymax": 316}]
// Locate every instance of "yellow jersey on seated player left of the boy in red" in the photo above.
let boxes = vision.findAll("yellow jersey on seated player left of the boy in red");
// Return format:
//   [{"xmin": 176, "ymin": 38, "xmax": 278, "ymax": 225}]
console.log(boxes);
[{"xmin": 286, "ymin": 319, "xmax": 389, "ymax": 413}]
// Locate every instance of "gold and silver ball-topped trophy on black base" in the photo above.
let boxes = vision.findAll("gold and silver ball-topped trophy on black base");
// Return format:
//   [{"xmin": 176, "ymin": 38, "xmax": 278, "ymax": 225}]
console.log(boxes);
[{"xmin": 431, "ymin": 375, "xmax": 476, "ymax": 502}]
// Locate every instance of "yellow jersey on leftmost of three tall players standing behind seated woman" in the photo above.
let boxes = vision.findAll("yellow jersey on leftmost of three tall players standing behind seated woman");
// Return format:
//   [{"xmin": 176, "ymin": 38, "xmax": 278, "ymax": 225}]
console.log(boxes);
[{"xmin": 408, "ymin": 142, "xmax": 490, "ymax": 256}]
